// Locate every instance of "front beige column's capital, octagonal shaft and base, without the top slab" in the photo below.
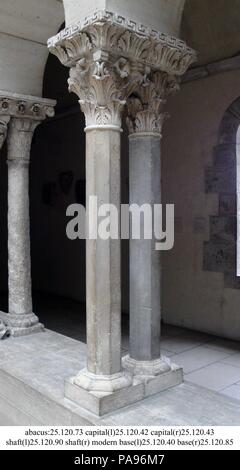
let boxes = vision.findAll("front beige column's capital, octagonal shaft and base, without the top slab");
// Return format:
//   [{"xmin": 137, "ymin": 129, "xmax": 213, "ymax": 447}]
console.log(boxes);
[{"xmin": 65, "ymin": 52, "xmax": 142, "ymax": 409}]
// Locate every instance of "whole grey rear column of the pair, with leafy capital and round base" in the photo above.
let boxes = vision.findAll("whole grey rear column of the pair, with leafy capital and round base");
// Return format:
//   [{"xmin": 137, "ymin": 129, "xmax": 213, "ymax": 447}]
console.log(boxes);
[{"xmin": 123, "ymin": 72, "xmax": 178, "ymax": 384}]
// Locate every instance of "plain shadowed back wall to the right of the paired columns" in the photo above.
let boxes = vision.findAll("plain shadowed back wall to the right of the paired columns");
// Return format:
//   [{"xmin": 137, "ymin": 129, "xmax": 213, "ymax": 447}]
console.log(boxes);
[{"xmin": 162, "ymin": 71, "xmax": 240, "ymax": 339}]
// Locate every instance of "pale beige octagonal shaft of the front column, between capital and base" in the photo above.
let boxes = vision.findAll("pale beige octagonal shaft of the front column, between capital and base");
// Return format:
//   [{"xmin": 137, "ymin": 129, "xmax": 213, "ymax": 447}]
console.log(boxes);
[{"xmin": 86, "ymin": 129, "xmax": 121, "ymax": 375}]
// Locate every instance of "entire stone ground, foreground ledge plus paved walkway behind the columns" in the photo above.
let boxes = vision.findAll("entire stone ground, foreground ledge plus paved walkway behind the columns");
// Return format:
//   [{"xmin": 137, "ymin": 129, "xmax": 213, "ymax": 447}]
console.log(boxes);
[{"xmin": 0, "ymin": 296, "xmax": 240, "ymax": 425}]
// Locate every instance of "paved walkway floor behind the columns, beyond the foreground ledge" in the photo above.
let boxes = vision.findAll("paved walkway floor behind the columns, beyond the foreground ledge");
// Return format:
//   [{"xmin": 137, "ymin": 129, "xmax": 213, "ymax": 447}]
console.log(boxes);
[{"xmin": 33, "ymin": 297, "xmax": 240, "ymax": 400}]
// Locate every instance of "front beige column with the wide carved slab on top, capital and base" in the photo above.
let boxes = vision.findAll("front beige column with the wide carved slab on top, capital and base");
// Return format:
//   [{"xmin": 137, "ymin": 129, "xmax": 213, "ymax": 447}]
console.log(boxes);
[{"xmin": 48, "ymin": 11, "xmax": 194, "ymax": 414}]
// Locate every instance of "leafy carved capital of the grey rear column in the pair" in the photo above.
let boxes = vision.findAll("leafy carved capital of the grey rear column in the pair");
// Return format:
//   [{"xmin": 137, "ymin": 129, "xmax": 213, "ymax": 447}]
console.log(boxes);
[{"xmin": 127, "ymin": 72, "xmax": 179, "ymax": 136}]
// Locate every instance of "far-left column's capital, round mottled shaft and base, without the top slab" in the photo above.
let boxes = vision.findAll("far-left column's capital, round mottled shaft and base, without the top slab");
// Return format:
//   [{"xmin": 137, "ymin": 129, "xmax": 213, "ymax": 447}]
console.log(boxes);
[{"xmin": 6, "ymin": 118, "xmax": 43, "ymax": 336}]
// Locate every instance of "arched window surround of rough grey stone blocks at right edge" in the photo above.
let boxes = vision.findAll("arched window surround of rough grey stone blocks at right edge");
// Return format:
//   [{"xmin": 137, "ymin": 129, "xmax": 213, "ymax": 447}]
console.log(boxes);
[{"xmin": 204, "ymin": 97, "xmax": 240, "ymax": 289}]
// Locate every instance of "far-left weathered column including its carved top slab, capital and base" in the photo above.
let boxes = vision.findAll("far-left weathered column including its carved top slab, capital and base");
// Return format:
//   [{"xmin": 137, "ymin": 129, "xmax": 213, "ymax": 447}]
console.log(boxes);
[{"xmin": 0, "ymin": 92, "xmax": 55, "ymax": 336}]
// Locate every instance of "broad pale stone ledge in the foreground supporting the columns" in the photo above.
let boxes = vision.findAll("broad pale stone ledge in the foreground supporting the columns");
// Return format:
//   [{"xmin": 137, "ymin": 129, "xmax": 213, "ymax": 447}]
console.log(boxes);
[{"xmin": 0, "ymin": 331, "xmax": 240, "ymax": 426}]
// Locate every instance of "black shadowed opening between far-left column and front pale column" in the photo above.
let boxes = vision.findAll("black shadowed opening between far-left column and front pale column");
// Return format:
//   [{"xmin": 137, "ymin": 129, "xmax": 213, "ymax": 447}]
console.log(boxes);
[{"xmin": 30, "ymin": 33, "xmax": 85, "ymax": 340}]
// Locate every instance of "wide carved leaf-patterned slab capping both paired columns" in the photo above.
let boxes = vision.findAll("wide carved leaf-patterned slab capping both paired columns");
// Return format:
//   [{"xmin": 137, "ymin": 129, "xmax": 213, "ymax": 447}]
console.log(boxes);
[{"xmin": 48, "ymin": 10, "xmax": 197, "ymax": 75}]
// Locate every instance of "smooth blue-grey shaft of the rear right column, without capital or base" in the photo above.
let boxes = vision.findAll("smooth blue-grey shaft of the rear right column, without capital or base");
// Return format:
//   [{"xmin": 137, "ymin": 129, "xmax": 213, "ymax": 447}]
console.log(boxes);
[{"xmin": 129, "ymin": 134, "xmax": 161, "ymax": 361}]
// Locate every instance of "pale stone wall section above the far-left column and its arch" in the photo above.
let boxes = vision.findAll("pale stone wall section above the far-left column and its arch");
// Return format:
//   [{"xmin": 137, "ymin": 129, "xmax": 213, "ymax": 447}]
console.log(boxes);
[{"xmin": 0, "ymin": 0, "xmax": 65, "ymax": 97}]
